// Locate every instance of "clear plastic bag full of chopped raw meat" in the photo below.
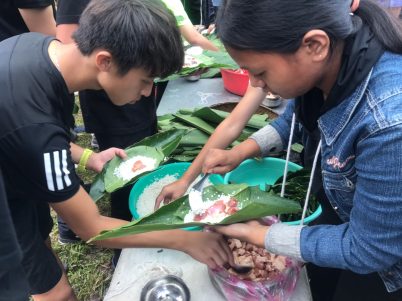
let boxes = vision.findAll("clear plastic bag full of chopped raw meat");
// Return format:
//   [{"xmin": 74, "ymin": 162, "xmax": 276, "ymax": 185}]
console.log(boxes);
[{"xmin": 208, "ymin": 218, "xmax": 302, "ymax": 301}]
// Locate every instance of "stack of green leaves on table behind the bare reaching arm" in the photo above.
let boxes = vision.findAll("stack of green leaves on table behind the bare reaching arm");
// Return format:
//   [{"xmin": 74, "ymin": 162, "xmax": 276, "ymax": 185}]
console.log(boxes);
[{"xmin": 158, "ymin": 107, "xmax": 271, "ymax": 161}]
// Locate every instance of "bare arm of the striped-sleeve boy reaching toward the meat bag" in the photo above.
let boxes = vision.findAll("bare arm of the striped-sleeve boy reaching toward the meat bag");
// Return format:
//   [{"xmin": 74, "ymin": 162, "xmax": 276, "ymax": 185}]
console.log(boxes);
[{"xmin": 50, "ymin": 187, "xmax": 231, "ymax": 268}]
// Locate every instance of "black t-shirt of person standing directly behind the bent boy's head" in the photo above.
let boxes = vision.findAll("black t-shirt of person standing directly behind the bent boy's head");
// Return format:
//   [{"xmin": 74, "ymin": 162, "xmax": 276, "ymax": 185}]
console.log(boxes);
[{"xmin": 56, "ymin": 0, "xmax": 156, "ymax": 134}]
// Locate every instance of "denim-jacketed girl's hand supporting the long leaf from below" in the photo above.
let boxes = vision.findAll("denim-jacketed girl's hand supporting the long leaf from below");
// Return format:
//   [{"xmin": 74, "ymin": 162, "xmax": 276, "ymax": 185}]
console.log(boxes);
[{"xmin": 214, "ymin": 221, "xmax": 269, "ymax": 248}]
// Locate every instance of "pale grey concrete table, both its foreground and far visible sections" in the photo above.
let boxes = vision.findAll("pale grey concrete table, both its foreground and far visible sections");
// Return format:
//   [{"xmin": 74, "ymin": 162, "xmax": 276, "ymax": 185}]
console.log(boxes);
[{"xmin": 104, "ymin": 78, "xmax": 311, "ymax": 301}]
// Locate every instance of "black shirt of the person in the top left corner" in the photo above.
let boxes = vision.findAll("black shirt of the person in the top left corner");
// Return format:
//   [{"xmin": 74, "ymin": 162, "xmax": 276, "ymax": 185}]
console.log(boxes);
[{"xmin": 0, "ymin": 0, "xmax": 54, "ymax": 41}]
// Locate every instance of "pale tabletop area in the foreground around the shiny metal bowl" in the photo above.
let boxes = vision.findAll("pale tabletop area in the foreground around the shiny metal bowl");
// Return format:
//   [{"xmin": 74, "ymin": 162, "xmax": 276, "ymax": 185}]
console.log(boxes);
[{"xmin": 104, "ymin": 248, "xmax": 312, "ymax": 301}]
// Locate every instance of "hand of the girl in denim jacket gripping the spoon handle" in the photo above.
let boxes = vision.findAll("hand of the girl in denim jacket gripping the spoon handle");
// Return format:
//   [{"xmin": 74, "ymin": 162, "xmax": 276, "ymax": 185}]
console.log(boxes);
[{"xmin": 202, "ymin": 149, "xmax": 242, "ymax": 174}]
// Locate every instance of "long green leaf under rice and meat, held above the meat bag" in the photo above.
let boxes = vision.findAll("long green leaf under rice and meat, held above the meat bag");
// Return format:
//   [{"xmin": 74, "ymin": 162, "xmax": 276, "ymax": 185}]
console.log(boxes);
[{"xmin": 89, "ymin": 184, "xmax": 301, "ymax": 242}]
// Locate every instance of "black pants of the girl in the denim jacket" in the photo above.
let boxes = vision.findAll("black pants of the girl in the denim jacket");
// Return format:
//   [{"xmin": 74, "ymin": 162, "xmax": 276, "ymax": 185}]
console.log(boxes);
[{"xmin": 307, "ymin": 193, "xmax": 402, "ymax": 301}]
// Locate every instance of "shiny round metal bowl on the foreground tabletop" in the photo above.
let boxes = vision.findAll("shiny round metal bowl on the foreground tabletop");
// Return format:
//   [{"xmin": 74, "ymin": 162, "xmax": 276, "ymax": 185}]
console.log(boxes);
[{"xmin": 141, "ymin": 275, "xmax": 190, "ymax": 301}]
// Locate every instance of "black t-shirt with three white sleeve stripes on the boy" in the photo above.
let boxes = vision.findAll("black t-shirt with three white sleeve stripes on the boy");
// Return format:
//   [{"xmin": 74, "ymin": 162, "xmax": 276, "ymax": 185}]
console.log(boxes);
[{"xmin": 0, "ymin": 33, "xmax": 80, "ymax": 207}]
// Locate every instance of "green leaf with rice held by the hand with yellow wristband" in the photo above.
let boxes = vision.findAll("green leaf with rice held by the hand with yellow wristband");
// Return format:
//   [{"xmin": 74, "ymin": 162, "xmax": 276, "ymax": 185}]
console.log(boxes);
[{"xmin": 104, "ymin": 145, "xmax": 165, "ymax": 192}]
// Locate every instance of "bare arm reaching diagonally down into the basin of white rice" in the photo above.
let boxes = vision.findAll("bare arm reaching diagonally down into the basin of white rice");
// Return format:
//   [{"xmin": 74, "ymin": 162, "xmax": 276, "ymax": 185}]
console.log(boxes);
[{"xmin": 155, "ymin": 86, "xmax": 265, "ymax": 208}]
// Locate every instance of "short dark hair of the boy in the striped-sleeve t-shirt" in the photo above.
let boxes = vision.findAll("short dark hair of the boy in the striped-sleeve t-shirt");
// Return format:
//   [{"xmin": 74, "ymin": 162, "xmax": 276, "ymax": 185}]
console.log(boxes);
[{"xmin": 73, "ymin": 0, "xmax": 184, "ymax": 77}]
